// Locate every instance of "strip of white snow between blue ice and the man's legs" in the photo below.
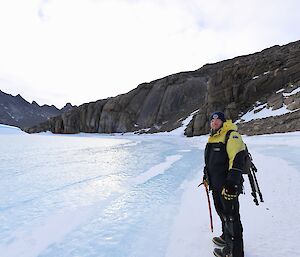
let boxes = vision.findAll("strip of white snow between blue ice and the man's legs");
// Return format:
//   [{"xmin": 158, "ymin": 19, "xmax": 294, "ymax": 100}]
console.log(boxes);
[{"xmin": 166, "ymin": 174, "xmax": 212, "ymax": 257}]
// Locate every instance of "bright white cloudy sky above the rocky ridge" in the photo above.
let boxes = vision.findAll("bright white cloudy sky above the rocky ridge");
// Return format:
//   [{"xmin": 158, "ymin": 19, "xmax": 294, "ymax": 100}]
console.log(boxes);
[{"xmin": 0, "ymin": 0, "xmax": 300, "ymax": 108}]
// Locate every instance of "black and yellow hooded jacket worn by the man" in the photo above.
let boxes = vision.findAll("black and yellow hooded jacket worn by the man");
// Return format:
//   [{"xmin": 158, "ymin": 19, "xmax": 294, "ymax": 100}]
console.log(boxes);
[{"xmin": 204, "ymin": 120, "xmax": 246, "ymax": 191}]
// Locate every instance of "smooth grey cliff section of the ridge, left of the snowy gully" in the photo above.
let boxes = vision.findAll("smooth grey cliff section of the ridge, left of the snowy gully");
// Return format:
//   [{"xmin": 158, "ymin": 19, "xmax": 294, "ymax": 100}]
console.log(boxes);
[{"xmin": 25, "ymin": 72, "xmax": 208, "ymax": 133}]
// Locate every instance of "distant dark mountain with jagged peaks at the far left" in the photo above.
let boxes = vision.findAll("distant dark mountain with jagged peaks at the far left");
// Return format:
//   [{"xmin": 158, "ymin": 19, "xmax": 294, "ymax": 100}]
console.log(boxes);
[{"xmin": 0, "ymin": 90, "xmax": 73, "ymax": 129}]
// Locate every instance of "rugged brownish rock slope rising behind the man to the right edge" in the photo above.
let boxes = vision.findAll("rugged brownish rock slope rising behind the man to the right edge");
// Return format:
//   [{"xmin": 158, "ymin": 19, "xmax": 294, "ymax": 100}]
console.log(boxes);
[{"xmin": 186, "ymin": 41, "xmax": 300, "ymax": 136}]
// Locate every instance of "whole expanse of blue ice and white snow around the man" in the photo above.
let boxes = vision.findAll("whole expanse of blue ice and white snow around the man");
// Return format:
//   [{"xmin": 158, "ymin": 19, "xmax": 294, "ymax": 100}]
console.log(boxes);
[{"xmin": 0, "ymin": 126, "xmax": 300, "ymax": 257}]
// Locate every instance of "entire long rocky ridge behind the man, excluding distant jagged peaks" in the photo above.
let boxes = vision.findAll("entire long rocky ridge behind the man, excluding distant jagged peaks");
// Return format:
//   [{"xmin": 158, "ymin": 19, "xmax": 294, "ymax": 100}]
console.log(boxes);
[{"xmin": 26, "ymin": 41, "xmax": 300, "ymax": 136}]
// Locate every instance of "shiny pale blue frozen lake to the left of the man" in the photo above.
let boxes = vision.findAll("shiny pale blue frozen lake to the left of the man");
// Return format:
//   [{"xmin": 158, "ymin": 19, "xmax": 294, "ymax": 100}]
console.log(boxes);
[{"xmin": 0, "ymin": 130, "xmax": 203, "ymax": 257}]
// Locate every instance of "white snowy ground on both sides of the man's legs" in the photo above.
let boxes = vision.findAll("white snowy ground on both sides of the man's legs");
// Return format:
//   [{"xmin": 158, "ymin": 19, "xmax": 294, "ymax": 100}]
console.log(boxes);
[{"xmin": 166, "ymin": 143, "xmax": 300, "ymax": 257}]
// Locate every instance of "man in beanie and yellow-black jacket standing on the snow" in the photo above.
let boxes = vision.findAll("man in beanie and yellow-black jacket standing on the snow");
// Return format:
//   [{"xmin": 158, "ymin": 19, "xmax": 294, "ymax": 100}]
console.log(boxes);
[{"xmin": 203, "ymin": 112, "xmax": 246, "ymax": 257}]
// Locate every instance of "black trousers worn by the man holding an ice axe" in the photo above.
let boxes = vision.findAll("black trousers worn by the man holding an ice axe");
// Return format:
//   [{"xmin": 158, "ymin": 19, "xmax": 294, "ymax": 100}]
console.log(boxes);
[{"xmin": 213, "ymin": 191, "xmax": 244, "ymax": 257}]
